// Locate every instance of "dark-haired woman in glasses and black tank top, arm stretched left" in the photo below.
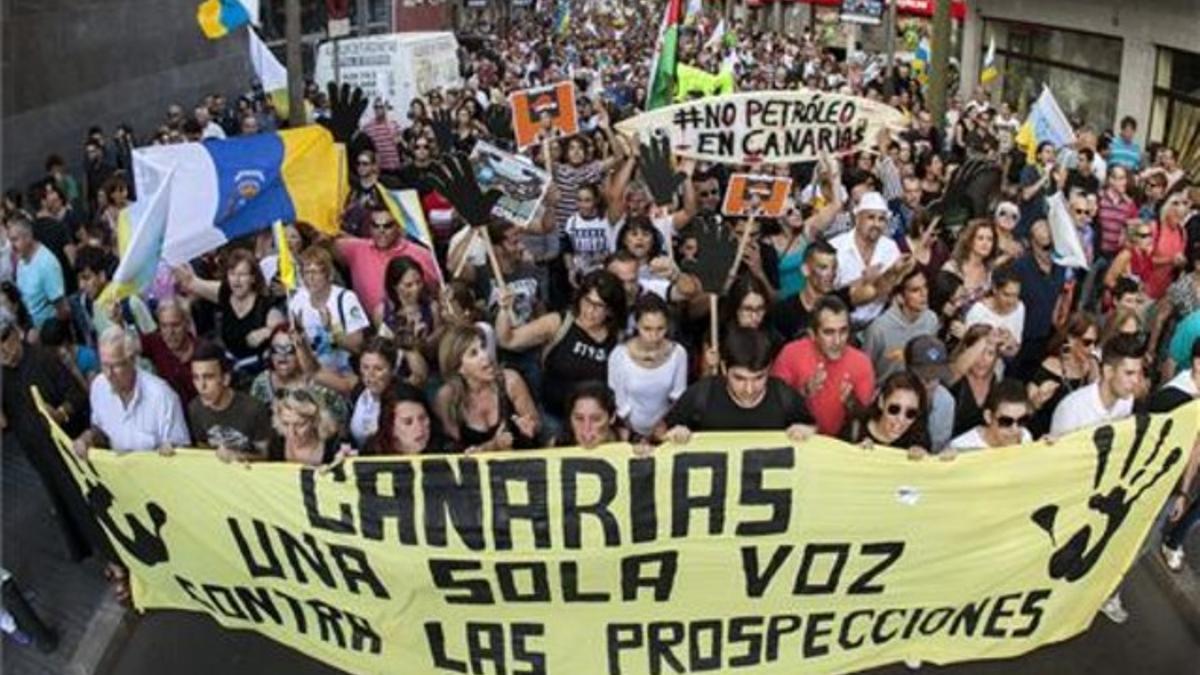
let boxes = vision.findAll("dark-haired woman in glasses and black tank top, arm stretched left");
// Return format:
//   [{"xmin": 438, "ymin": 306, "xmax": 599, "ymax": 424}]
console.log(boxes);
[{"xmin": 496, "ymin": 270, "xmax": 625, "ymax": 419}]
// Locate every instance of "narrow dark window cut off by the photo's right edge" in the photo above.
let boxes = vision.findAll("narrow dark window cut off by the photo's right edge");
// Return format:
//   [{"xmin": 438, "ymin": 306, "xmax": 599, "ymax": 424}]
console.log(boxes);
[{"xmin": 1150, "ymin": 48, "xmax": 1200, "ymax": 181}]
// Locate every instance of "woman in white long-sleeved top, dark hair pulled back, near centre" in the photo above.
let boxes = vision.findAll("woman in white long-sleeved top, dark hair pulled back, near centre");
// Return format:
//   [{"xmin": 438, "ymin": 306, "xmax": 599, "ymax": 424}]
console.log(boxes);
[{"xmin": 608, "ymin": 293, "xmax": 688, "ymax": 436}]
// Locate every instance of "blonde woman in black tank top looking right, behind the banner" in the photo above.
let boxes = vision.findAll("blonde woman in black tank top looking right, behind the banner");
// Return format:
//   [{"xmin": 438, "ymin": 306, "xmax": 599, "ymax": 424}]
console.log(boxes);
[{"xmin": 434, "ymin": 325, "xmax": 541, "ymax": 453}]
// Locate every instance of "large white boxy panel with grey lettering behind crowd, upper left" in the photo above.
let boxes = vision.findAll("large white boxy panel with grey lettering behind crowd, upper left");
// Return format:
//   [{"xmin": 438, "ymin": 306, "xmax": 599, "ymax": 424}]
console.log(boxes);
[{"xmin": 313, "ymin": 32, "xmax": 462, "ymax": 115}]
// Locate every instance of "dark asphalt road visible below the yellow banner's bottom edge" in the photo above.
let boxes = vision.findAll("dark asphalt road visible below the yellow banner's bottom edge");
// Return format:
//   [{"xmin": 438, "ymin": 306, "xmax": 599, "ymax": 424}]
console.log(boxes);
[{"xmin": 106, "ymin": 561, "xmax": 1200, "ymax": 675}]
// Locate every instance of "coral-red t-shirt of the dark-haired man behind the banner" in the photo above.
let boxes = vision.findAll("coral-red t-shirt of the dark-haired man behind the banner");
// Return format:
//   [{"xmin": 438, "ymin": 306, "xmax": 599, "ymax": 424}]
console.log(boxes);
[{"xmin": 770, "ymin": 338, "xmax": 875, "ymax": 436}]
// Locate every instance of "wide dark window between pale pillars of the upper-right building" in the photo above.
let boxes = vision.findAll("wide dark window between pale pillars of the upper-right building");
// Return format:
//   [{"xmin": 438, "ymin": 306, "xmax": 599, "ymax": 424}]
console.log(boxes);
[{"xmin": 984, "ymin": 20, "xmax": 1122, "ymax": 130}]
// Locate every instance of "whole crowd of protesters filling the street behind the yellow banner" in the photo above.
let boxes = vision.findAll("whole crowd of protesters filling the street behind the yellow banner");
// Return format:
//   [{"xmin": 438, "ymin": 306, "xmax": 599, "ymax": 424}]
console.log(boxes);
[{"xmin": 0, "ymin": 5, "xmax": 1200, "ymax": 648}]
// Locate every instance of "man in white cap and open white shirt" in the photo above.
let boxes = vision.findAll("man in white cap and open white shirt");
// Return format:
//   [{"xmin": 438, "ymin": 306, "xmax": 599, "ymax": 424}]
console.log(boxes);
[{"xmin": 829, "ymin": 192, "xmax": 914, "ymax": 330}]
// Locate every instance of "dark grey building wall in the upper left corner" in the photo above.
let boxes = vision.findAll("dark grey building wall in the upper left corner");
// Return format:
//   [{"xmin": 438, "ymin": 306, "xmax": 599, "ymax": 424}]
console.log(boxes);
[{"xmin": 0, "ymin": 0, "xmax": 252, "ymax": 189}]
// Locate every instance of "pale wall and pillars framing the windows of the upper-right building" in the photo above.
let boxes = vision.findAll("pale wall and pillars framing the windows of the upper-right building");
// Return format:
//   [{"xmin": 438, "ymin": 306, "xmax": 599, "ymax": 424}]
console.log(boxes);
[{"xmin": 960, "ymin": 0, "xmax": 1200, "ymax": 142}]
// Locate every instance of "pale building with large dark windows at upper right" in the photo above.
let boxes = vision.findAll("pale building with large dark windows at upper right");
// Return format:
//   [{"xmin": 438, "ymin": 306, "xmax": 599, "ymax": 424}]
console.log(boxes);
[{"xmin": 960, "ymin": 0, "xmax": 1200, "ymax": 173}]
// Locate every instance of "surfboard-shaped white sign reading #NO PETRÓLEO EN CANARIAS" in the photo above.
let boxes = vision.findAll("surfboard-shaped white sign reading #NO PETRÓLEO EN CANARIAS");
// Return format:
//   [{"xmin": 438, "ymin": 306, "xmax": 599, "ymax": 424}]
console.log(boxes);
[{"xmin": 617, "ymin": 89, "xmax": 904, "ymax": 165}]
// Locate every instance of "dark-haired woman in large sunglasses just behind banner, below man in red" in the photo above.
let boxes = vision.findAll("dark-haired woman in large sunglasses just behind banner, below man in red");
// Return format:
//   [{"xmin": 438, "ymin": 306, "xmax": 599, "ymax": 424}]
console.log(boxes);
[{"xmin": 846, "ymin": 372, "xmax": 929, "ymax": 455}]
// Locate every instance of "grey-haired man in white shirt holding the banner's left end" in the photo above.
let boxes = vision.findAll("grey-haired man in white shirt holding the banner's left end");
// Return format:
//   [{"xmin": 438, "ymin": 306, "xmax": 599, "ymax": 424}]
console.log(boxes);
[{"xmin": 74, "ymin": 325, "xmax": 191, "ymax": 458}]
